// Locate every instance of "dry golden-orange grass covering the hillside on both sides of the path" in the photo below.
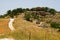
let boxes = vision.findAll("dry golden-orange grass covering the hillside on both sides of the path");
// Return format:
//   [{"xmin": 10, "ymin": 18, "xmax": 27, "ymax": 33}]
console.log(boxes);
[{"xmin": 0, "ymin": 14, "xmax": 60, "ymax": 40}]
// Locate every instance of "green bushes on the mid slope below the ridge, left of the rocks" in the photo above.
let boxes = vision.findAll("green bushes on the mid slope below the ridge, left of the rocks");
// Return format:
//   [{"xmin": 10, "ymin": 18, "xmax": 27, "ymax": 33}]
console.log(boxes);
[{"xmin": 24, "ymin": 12, "xmax": 39, "ymax": 22}]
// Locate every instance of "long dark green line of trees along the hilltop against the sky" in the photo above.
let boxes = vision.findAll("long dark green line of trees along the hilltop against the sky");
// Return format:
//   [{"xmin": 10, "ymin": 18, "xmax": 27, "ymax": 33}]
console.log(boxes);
[{"xmin": 0, "ymin": 7, "xmax": 57, "ymax": 18}]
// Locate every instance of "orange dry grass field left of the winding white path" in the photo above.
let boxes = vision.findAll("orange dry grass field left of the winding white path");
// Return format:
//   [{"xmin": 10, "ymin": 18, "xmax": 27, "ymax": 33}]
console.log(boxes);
[{"xmin": 0, "ymin": 18, "xmax": 10, "ymax": 34}]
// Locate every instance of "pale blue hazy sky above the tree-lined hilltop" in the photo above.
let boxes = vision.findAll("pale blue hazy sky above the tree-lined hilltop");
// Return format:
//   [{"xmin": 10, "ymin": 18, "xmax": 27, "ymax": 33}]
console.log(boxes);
[{"xmin": 0, "ymin": 0, "xmax": 60, "ymax": 15}]
